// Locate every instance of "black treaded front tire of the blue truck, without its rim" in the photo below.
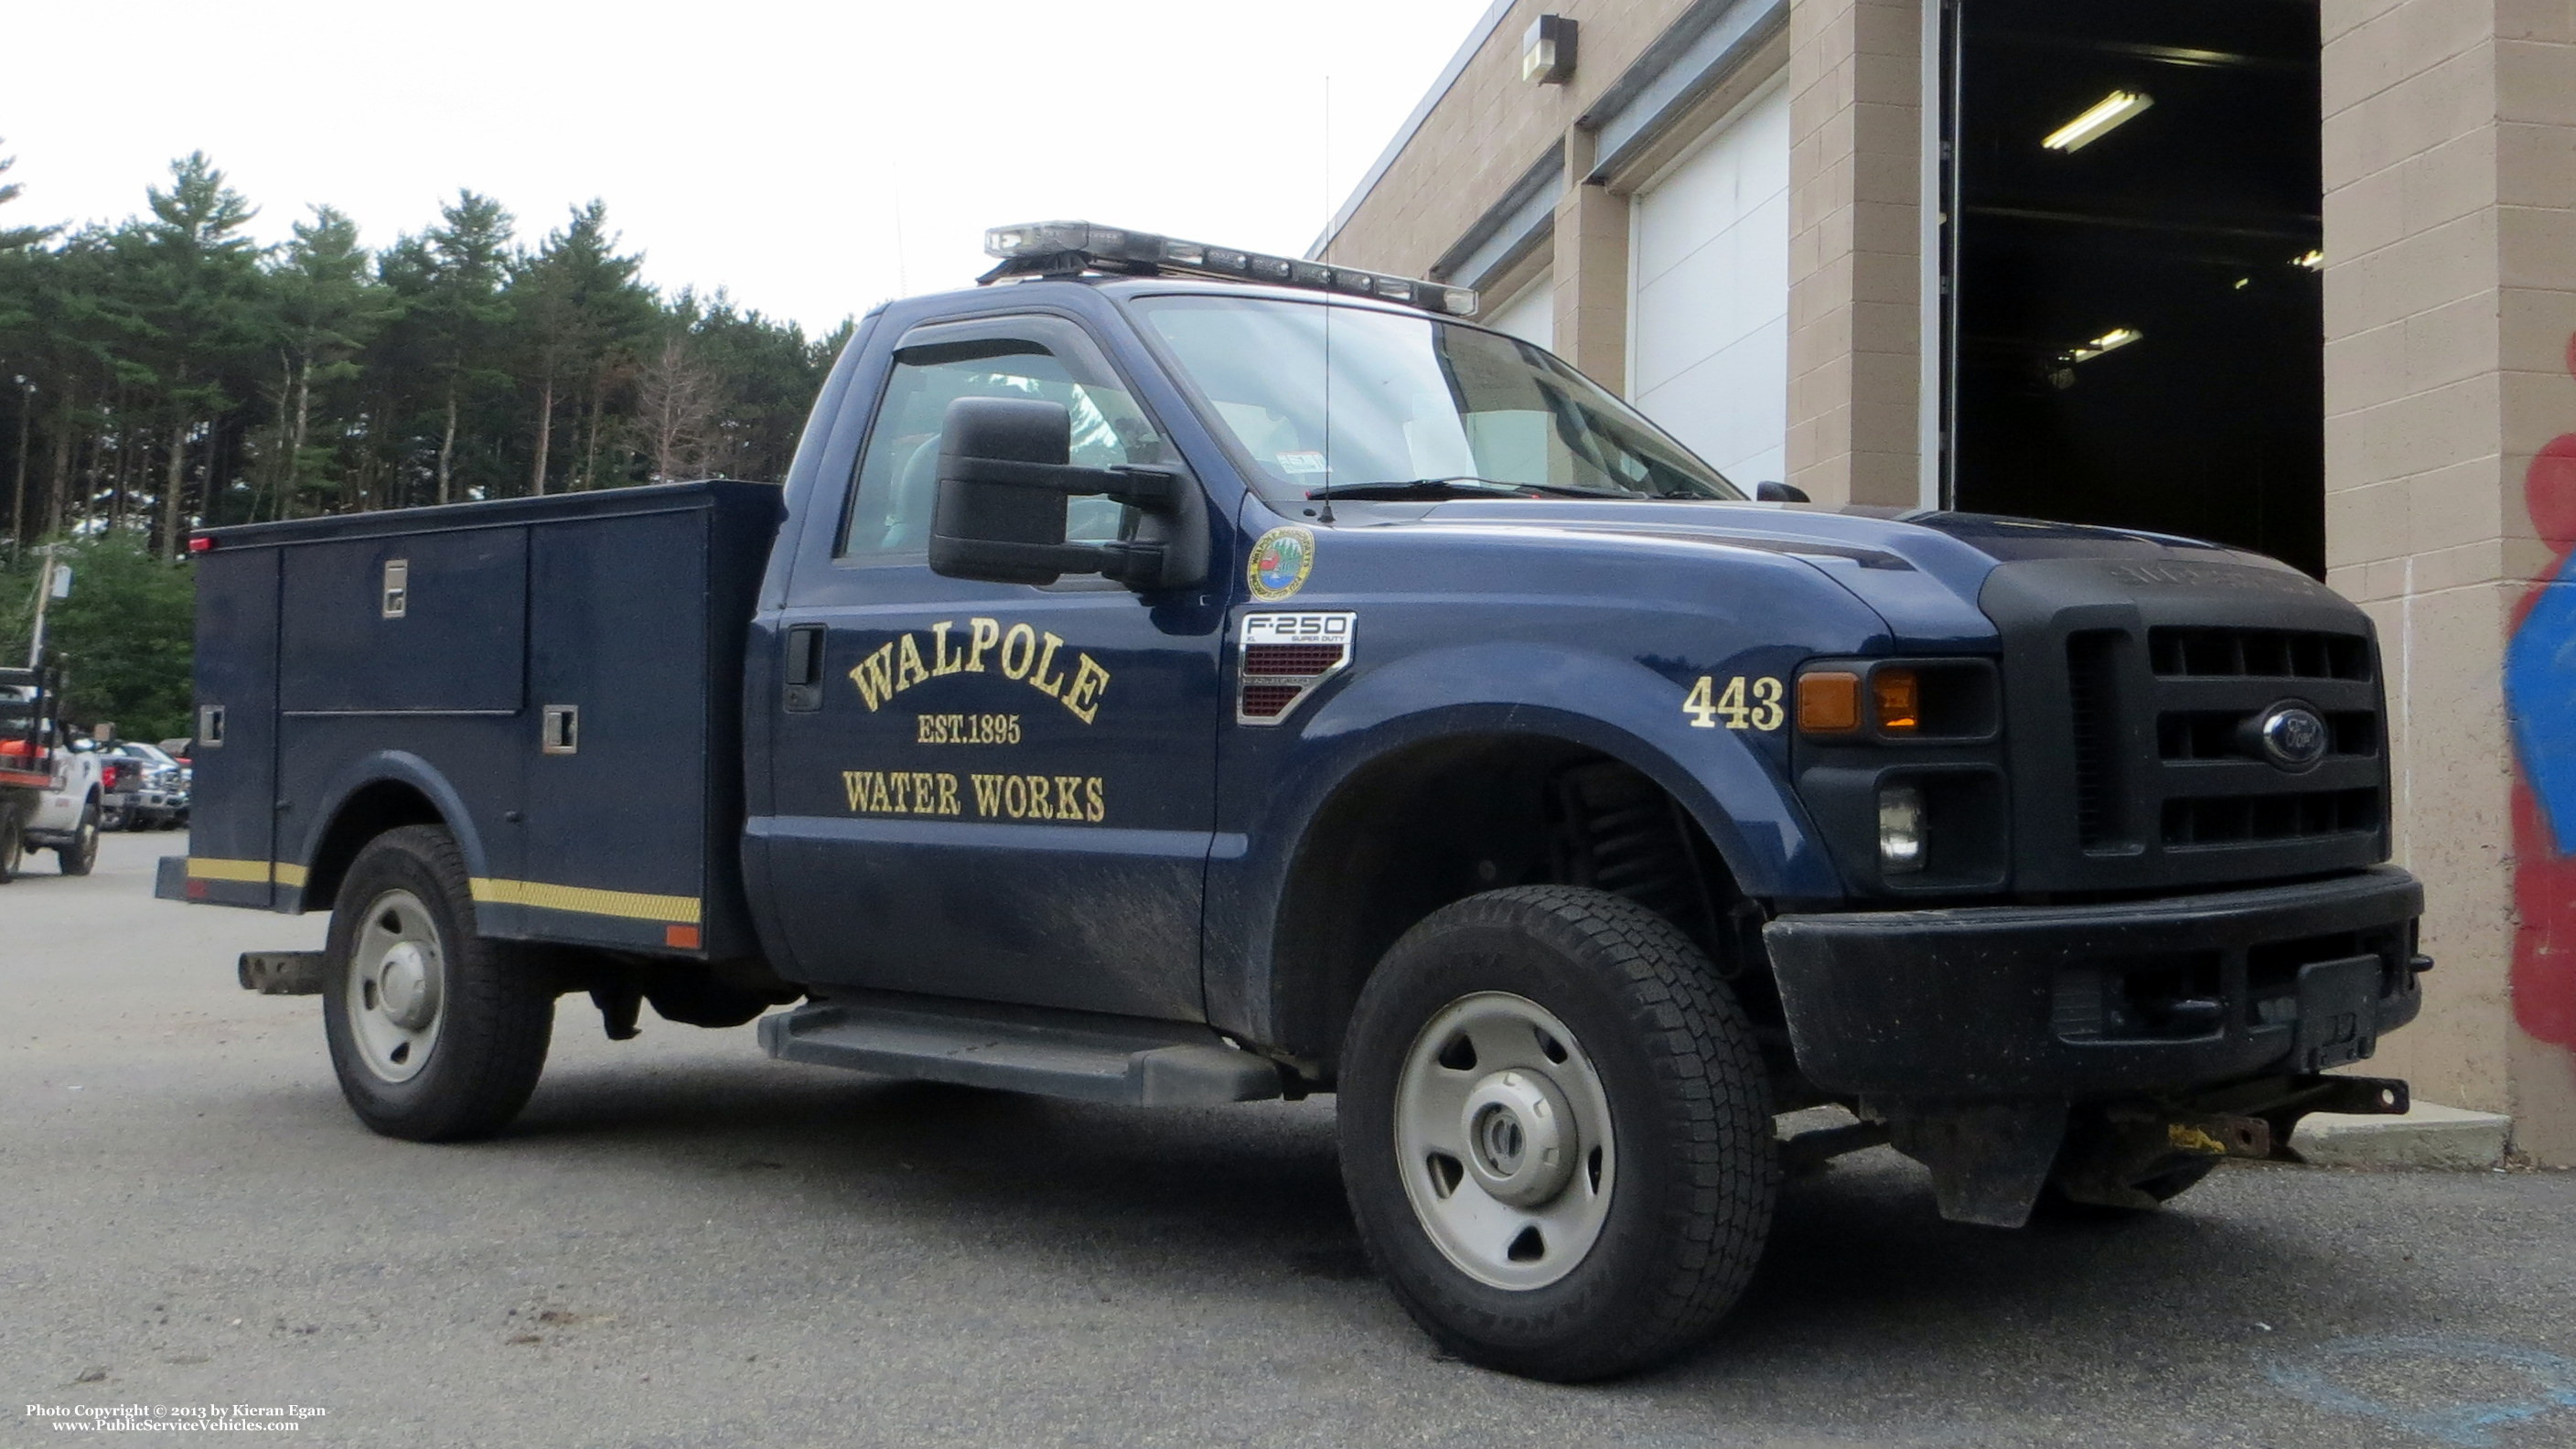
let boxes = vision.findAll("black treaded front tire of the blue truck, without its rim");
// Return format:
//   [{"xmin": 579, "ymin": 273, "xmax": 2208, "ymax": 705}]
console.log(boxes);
[{"xmin": 1339, "ymin": 887, "xmax": 1777, "ymax": 1382}]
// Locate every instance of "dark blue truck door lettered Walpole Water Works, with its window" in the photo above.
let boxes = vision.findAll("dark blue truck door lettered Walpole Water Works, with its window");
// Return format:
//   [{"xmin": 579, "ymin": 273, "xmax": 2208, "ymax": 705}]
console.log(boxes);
[{"xmin": 770, "ymin": 315, "xmax": 1224, "ymax": 1021}]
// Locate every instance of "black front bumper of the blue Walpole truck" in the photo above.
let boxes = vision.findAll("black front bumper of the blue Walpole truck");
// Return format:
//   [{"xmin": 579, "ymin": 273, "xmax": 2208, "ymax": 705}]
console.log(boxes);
[{"xmin": 1765, "ymin": 866, "xmax": 2429, "ymax": 1099}]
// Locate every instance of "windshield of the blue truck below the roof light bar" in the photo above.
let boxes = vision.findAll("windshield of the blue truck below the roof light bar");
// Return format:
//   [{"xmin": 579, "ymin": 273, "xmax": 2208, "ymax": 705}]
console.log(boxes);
[{"xmin": 1136, "ymin": 296, "xmax": 1744, "ymax": 503}]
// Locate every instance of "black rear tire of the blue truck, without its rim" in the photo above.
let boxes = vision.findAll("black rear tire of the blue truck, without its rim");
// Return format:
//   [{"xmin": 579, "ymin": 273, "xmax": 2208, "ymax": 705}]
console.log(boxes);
[{"xmin": 322, "ymin": 825, "xmax": 553, "ymax": 1143}]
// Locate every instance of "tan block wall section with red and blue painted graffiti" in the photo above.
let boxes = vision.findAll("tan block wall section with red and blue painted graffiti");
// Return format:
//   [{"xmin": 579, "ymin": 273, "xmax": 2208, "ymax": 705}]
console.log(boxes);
[{"xmin": 2321, "ymin": 0, "xmax": 2576, "ymax": 1163}]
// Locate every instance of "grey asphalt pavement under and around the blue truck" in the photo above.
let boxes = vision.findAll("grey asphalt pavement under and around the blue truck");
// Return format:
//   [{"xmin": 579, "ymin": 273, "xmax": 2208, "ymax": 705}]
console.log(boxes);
[{"xmin": 0, "ymin": 835, "xmax": 2576, "ymax": 1449}]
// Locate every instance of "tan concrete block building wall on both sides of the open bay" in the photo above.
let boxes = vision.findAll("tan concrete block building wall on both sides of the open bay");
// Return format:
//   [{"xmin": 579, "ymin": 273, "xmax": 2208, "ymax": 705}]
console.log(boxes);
[{"xmin": 1332, "ymin": 0, "xmax": 2576, "ymax": 1163}]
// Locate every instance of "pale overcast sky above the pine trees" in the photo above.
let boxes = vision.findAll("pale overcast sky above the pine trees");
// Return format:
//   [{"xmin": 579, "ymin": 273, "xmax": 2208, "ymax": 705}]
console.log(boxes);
[{"xmin": 0, "ymin": 0, "xmax": 1489, "ymax": 330}]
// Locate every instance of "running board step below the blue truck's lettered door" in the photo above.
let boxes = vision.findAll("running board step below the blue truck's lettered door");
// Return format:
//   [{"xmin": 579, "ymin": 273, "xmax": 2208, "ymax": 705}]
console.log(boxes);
[{"xmin": 760, "ymin": 993, "xmax": 1281, "ymax": 1106}]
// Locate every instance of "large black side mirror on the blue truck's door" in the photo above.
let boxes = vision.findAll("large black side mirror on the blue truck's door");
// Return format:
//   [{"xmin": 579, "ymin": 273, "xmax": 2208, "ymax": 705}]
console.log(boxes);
[{"xmin": 930, "ymin": 397, "xmax": 1208, "ymax": 590}]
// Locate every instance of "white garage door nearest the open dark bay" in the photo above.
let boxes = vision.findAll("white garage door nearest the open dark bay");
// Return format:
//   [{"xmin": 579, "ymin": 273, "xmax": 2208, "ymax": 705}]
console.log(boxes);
[{"xmin": 1628, "ymin": 85, "xmax": 1787, "ymax": 490}]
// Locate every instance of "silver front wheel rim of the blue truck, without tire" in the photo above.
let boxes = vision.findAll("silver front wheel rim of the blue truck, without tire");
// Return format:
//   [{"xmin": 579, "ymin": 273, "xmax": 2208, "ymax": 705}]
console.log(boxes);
[{"xmin": 1396, "ymin": 990, "xmax": 1617, "ymax": 1292}]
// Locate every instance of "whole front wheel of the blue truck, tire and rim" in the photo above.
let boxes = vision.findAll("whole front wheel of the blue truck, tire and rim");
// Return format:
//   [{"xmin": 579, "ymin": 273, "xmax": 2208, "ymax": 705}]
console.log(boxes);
[{"xmin": 1339, "ymin": 887, "xmax": 1777, "ymax": 1379}]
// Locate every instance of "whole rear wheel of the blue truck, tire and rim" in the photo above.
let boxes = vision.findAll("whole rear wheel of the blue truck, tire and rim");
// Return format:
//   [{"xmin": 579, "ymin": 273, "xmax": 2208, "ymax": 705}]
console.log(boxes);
[{"xmin": 322, "ymin": 825, "xmax": 553, "ymax": 1143}]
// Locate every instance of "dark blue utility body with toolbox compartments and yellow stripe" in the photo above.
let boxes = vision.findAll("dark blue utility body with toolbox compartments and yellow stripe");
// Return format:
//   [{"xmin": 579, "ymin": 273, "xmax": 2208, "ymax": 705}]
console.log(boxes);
[{"xmin": 160, "ymin": 482, "xmax": 780, "ymax": 959}]
